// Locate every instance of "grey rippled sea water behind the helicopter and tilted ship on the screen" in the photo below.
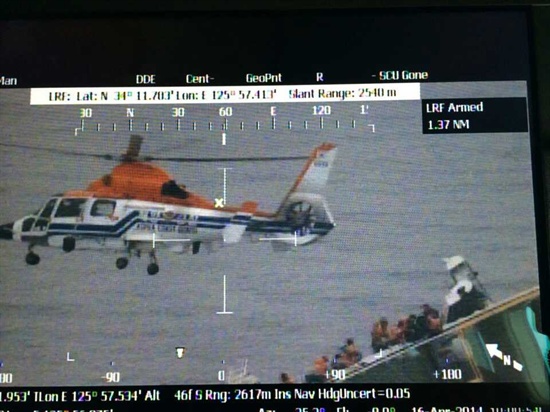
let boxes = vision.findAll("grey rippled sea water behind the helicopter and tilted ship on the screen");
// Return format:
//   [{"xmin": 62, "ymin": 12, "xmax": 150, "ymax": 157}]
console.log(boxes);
[{"xmin": 0, "ymin": 90, "xmax": 538, "ymax": 385}]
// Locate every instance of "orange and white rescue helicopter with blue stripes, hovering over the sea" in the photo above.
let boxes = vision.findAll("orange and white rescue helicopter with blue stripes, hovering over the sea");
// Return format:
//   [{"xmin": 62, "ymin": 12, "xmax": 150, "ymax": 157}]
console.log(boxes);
[{"xmin": 0, "ymin": 135, "xmax": 336, "ymax": 275}]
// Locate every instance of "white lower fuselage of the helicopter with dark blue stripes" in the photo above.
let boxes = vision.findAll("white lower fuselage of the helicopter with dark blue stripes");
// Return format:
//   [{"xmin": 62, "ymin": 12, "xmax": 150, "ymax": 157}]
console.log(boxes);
[{"xmin": 12, "ymin": 196, "xmax": 334, "ymax": 253}]
